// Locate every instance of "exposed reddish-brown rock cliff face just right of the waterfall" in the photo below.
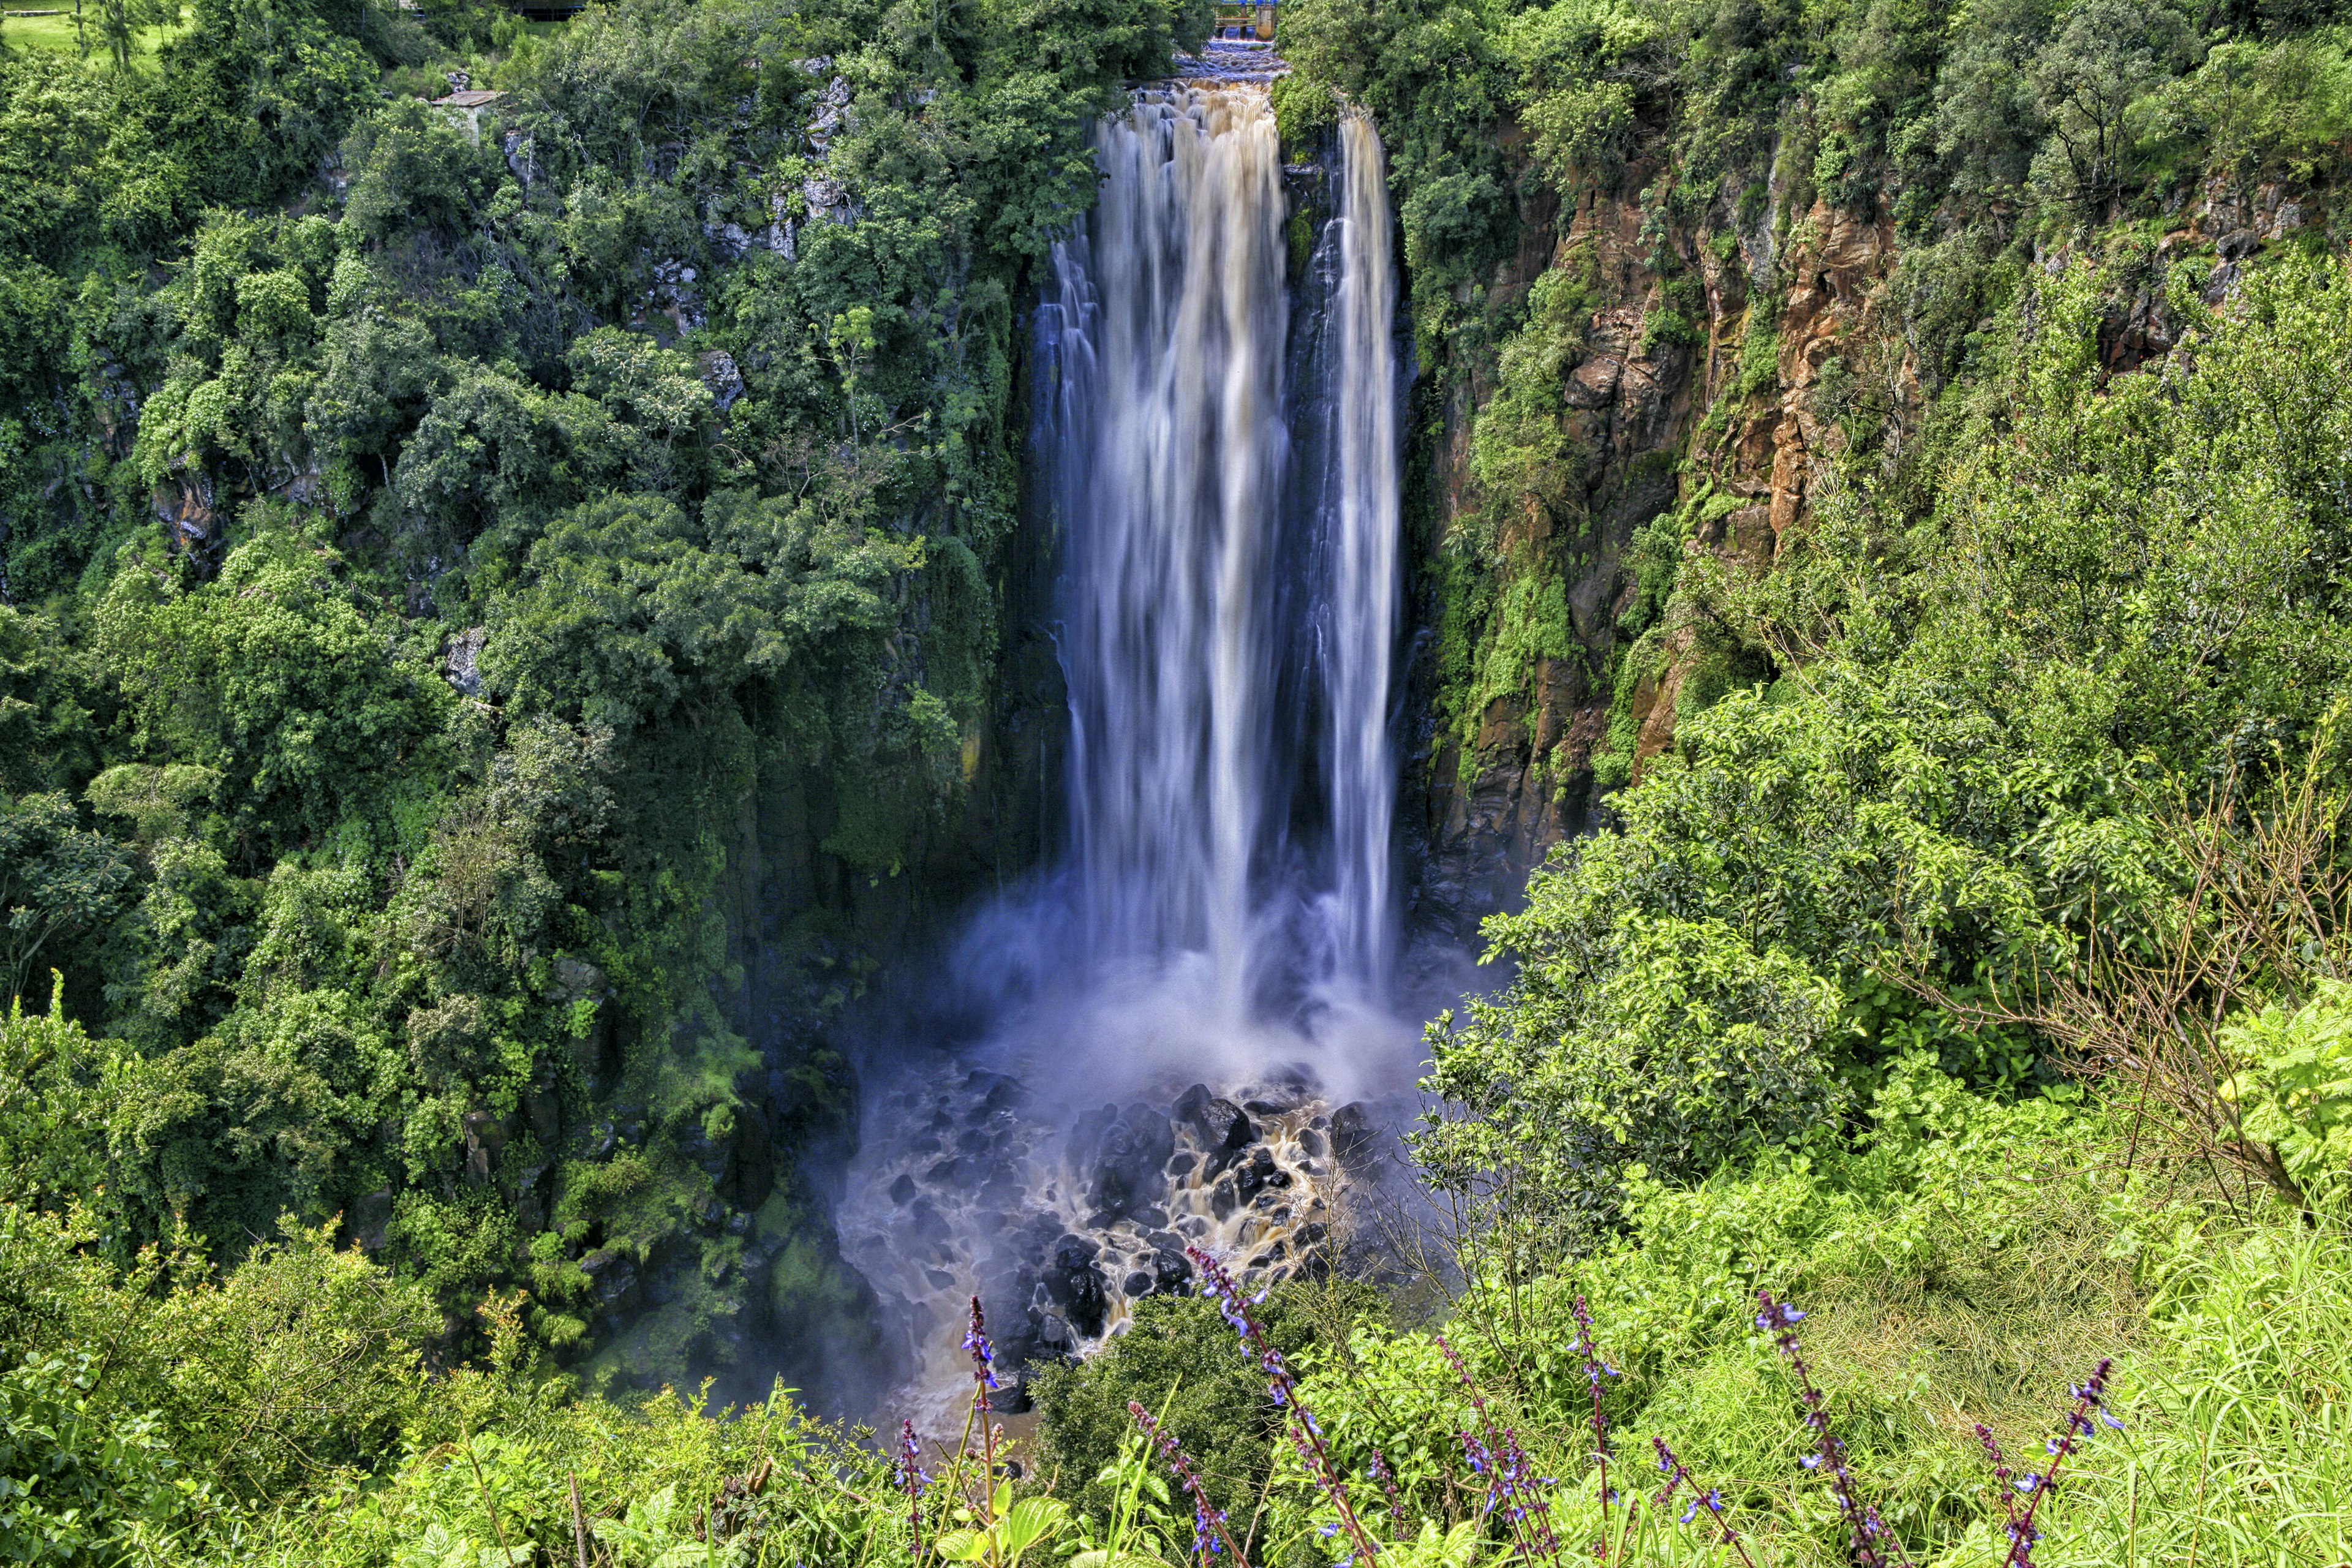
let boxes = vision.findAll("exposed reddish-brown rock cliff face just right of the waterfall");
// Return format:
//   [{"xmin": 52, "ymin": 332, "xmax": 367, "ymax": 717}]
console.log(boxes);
[{"xmin": 1392, "ymin": 145, "xmax": 1917, "ymax": 924}]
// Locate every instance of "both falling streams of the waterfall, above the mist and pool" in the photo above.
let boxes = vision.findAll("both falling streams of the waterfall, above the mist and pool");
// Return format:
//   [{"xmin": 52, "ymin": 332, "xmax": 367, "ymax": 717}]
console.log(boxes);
[{"xmin": 1039, "ymin": 87, "xmax": 1400, "ymax": 1023}]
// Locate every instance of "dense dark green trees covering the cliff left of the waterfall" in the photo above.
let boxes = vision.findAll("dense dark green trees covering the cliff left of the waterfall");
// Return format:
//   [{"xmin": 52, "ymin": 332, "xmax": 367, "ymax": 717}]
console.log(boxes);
[{"xmin": 0, "ymin": 0, "xmax": 1207, "ymax": 1399}]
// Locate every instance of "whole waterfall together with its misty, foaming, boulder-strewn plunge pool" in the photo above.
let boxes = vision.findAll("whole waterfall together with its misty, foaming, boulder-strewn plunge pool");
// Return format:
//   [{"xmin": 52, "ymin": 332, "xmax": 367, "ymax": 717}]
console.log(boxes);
[{"xmin": 840, "ymin": 85, "xmax": 1419, "ymax": 1413}]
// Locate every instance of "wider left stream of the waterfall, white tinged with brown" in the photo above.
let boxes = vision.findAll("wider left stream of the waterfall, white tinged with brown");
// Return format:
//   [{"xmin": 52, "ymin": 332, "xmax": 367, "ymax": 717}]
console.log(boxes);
[{"xmin": 1051, "ymin": 89, "xmax": 1286, "ymax": 1016}]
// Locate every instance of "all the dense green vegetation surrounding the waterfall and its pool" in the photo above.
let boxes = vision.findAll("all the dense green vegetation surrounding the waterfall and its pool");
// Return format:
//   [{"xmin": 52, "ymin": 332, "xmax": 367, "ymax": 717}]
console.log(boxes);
[{"xmin": 0, "ymin": 0, "xmax": 2352, "ymax": 1568}]
